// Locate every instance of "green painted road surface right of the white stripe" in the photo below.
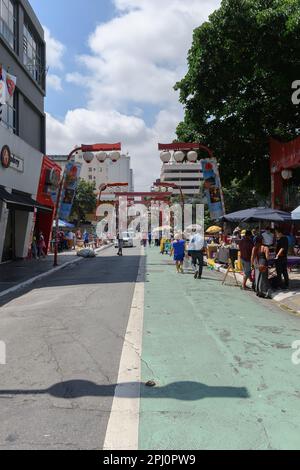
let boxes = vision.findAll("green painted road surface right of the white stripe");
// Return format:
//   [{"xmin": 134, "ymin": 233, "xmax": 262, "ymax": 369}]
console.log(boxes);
[{"xmin": 139, "ymin": 248, "xmax": 300, "ymax": 450}]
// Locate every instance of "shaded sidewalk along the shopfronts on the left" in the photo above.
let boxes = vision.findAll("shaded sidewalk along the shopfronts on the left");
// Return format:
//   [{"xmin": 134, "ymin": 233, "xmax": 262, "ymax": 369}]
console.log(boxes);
[{"xmin": 0, "ymin": 245, "xmax": 110, "ymax": 297}]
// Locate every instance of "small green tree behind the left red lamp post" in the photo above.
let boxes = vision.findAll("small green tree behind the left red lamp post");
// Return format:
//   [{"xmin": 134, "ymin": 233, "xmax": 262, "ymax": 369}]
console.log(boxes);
[{"xmin": 72, "ymin": 179, "xmax": 97, "ymax": 221}]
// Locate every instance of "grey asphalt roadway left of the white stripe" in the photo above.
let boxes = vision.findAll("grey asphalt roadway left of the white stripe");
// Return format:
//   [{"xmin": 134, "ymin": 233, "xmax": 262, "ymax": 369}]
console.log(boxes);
[{"xmin": 0, "ymin": 244, "xmax": 140, "ymax": 449}]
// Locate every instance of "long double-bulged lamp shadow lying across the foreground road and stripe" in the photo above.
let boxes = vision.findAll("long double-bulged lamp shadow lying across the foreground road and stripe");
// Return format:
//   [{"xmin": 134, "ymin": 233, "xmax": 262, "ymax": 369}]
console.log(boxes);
[{"xmin": 0, "ymin": 380, "xmax": 250, "ymax": 401}]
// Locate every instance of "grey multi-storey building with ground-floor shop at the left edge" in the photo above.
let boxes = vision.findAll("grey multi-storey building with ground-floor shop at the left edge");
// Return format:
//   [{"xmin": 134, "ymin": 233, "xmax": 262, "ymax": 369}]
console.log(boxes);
[{"xmin": 0, "ymin": 0, "xmax": 46, "ymax": 262}]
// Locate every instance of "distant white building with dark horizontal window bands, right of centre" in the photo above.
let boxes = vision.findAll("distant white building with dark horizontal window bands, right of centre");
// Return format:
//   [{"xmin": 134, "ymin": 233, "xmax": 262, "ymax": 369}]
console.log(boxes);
[{"xmin": 160, "ymin": 160, "xmax": 203, "ymax": 197}]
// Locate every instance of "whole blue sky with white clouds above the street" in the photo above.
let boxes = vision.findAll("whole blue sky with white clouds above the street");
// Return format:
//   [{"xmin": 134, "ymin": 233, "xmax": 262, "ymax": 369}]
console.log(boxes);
[{"xmin": 30, "ymin": 0, "xmax": 220, "ymax": 191}]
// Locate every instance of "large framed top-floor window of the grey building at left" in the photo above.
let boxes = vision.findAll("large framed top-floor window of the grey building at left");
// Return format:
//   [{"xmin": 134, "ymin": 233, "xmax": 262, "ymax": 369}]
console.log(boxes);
[{"xmin": 23, "ymin": 24, "xmax": 44, "ymax": 86}]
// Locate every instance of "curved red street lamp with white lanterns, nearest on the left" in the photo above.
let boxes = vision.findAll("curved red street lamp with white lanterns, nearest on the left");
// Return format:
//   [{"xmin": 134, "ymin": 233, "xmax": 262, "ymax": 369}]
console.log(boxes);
[{"xmin": 53, "ymin": 143, "xmax": 121, "ymax": 266}]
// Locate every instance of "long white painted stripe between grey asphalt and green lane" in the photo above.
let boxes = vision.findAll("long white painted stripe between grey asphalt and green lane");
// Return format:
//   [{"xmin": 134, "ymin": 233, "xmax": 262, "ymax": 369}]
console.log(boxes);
[{"xmin": 103, "ymin": 248, "xmax": 145, "ymax": 450}]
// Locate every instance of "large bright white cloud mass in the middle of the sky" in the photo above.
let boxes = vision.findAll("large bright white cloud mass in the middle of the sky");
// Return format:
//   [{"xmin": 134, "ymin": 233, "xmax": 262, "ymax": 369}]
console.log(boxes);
[{"xmin": 48, "ymin": 0, "xmax": 220, "ymax": 189}]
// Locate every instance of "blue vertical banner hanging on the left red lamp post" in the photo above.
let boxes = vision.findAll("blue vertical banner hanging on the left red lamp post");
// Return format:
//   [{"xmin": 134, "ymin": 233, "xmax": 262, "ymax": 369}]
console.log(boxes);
[{"xmin": 59, "ymin": 162, "xmax": 81, "ymax": 220}]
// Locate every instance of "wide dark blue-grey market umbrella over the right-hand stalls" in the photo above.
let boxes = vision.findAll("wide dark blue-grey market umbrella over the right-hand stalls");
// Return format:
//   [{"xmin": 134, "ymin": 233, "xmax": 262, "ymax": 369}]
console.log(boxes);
[{"xmin": 221, "ymin": 207, "xmax": 292, "ymax": 222}]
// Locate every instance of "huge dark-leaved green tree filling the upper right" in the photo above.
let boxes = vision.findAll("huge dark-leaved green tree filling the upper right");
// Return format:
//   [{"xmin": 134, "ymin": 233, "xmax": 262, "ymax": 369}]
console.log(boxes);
[{"xmin": 175, "ymin": 0, "xmax": 300, "ymax": 195}]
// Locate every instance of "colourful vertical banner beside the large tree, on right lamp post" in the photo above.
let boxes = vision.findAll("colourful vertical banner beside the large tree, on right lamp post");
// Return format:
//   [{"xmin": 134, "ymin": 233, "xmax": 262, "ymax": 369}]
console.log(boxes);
[{"xmin": 202, "ymin": 158, "xmax": 225, "ymax": 220}]
